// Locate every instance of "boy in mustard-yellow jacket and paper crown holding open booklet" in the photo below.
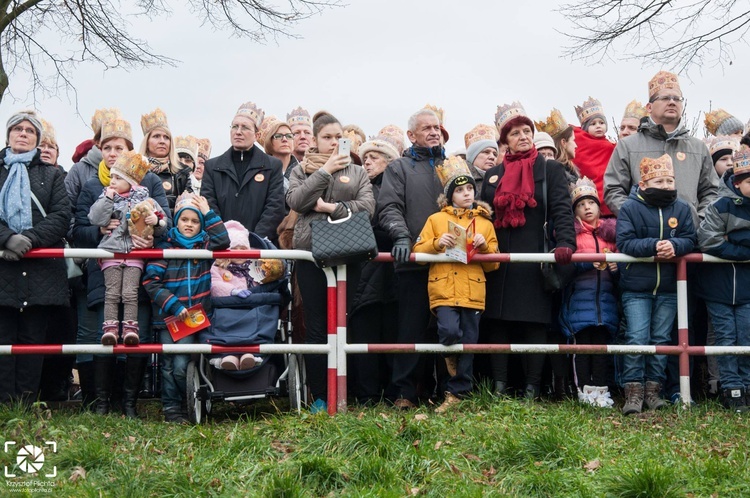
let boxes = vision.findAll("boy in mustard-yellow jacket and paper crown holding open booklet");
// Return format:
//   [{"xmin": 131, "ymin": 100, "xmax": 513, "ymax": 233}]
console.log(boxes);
[{"xmin": 414, "ymin": 156, "xmax": 499, "ymax": 413}]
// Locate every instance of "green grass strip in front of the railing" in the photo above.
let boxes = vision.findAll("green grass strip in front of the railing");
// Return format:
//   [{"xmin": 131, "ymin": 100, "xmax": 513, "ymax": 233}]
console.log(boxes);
[{"xmin": 0, "ymin": 391, "xmax": 750, "ymax": 498}]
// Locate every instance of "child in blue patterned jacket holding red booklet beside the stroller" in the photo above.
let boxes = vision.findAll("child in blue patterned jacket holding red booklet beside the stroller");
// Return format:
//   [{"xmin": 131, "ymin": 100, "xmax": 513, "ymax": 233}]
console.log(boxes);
[{"xmin": 143, "ymin": 193, "xmax": 229, "ymax": 423}]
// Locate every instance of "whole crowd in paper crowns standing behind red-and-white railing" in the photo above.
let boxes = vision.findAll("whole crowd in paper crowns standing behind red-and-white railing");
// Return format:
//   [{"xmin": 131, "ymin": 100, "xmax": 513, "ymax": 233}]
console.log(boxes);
[{"xmin": 0, "ymin": 71, "xmax": 750, "ymax": 423}]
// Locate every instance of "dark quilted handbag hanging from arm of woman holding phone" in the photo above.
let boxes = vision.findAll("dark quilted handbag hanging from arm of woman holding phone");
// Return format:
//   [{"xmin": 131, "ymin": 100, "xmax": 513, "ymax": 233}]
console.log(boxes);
[{"xmin": 311, "ymin": 203, "xmax": 378, "ymax": 268}]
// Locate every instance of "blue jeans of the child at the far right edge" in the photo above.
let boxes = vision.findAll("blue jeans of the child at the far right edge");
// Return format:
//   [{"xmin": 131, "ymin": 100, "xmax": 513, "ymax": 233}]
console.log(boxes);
[{"xmin": 706, "ymin": 301, "xmax": 750, "ymax": 389}]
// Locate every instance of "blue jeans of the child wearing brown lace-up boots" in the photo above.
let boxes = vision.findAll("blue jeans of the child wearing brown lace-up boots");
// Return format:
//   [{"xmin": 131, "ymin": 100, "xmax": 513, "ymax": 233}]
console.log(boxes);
[{"xmin": 622, "ymin": 292, "xmax": 677, "ymax": 384}]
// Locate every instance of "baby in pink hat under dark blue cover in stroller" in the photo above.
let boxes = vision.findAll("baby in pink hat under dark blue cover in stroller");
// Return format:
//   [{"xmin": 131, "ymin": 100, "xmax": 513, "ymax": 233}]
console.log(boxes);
[{"xmin": 206, "ymin": 220, "xmax": 291, "ymax": 376}]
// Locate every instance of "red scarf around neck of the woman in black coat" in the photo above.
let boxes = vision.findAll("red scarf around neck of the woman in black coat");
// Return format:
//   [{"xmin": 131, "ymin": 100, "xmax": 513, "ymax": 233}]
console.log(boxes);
[{"xmin": 493, "ymin": 147, "xmax": 539, "ymax": 228}]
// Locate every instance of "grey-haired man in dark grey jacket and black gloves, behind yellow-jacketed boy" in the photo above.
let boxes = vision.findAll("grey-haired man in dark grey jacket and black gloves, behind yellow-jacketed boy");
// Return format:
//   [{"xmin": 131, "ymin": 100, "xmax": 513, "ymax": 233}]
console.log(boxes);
[{"xmin": 376, "ymin": 109, "xmax": 445, "ymax": 409}]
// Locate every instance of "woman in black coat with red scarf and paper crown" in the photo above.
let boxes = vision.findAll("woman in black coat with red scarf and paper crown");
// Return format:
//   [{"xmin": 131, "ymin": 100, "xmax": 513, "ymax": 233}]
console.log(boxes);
[{"xmin": 480, "ymin": 102, "xmax": 576, "ymax": 399}]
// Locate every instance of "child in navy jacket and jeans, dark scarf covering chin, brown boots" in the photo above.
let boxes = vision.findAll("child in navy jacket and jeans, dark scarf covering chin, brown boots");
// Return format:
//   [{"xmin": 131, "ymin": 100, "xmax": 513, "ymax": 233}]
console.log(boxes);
[{"xmin": 617, "ymin": 154, "xmax": 696, "ymax": 415}]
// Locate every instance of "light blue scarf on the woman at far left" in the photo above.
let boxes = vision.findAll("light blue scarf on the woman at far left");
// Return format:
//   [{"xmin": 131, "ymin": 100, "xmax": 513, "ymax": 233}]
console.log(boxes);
[{"xmin": 0, "ymin": 148, "xmax": 38, "ymax": 233}]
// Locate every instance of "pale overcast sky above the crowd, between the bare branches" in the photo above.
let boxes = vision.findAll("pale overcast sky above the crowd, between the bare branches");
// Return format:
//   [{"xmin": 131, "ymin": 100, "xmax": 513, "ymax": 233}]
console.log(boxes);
[{"xmin": 0, "ymin": 0, "xmax": 750, "ymax": 167}]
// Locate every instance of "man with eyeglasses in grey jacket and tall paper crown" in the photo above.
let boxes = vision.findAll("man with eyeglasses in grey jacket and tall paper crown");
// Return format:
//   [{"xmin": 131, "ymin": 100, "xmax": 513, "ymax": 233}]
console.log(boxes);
[{"xmin": 604, "ymin": 71, "xmax": 718, "ymax": 222}]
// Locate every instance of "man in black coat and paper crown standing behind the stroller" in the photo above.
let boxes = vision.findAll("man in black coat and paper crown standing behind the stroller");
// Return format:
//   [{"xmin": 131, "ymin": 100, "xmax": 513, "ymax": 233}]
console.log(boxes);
[{"xmin": 201, "ymin": 102, "xmax": 284, "ymax": 242}]
